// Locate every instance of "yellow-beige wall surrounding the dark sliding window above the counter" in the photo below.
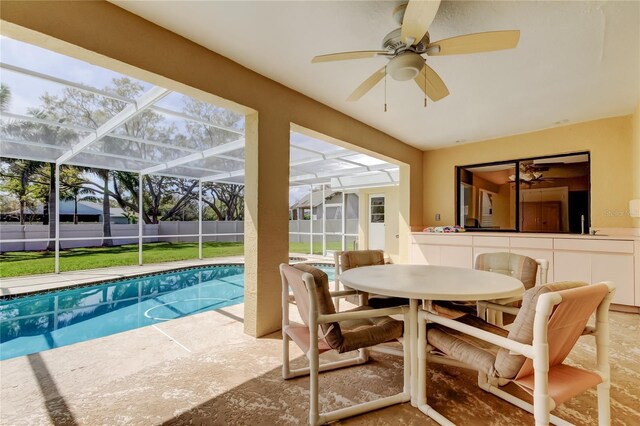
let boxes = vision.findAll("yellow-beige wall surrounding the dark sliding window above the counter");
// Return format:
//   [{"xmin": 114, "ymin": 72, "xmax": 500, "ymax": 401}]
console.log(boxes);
[{"xmin": 423, "ymin": 116, "xmax": 640, "ymax": 228}]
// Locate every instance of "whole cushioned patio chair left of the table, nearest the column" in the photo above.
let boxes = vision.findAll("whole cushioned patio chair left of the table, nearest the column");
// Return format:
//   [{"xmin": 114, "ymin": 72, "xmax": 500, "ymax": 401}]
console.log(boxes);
[{"xmin": 280, "ymin": 263, "xmax": 410, "ymax": 425}]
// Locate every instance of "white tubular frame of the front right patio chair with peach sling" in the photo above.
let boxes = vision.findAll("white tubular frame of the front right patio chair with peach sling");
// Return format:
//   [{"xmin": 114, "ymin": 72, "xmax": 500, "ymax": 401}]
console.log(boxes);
[{"xmin": 418, "ymin": 281, "xmax": 615, "ymax": 426}]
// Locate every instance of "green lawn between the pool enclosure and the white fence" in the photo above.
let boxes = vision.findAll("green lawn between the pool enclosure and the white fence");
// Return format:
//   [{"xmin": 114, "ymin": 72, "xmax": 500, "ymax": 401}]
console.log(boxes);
[{"xmin": 0, "ymin": 242, "xmax": 348, "ymax": 278}]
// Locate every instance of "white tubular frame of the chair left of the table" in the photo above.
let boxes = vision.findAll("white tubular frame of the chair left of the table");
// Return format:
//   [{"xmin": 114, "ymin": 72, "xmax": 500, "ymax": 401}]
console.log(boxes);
[{"xmin": 280, "ymin": 265, "xmax": 411, "ymax": 426}]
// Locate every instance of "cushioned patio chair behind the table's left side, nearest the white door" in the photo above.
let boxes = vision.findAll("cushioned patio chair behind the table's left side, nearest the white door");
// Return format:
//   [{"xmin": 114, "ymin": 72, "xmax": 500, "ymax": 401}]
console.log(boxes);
[{"xmin": 333, "ymin": 250, "xmax": 409, "ymax": 310}]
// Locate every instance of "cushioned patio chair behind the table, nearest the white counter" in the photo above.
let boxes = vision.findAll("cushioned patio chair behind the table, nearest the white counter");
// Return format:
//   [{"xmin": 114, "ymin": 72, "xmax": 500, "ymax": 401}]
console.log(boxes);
[{"xmin": 433, "ymin": 252, "xmax": 549, "ymax": 326}]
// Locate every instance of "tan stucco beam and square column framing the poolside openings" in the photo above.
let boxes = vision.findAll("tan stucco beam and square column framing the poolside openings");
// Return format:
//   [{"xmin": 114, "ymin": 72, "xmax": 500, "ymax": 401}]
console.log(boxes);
[{"xmin": 0, "ymin": 1, "xmax": 423, "ymax": 336}]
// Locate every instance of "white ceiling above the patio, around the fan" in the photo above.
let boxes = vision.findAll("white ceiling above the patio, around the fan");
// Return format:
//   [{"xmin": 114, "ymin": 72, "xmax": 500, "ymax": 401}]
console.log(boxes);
[{"xmin": 114, "ymin": 0, "xmax": 640, "ymax": 149}]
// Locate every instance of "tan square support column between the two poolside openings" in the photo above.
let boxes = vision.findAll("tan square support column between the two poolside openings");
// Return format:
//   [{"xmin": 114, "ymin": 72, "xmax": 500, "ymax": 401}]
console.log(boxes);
[{"xmin": 244, "ymin": 112, "xmax": 290, "ymax": 337}]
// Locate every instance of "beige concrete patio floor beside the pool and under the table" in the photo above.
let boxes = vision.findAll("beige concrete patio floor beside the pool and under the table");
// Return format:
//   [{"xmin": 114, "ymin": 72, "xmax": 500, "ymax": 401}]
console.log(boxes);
[{"xmin": 0, "ymin": 305, "xmax": 640, "ymax": 425}]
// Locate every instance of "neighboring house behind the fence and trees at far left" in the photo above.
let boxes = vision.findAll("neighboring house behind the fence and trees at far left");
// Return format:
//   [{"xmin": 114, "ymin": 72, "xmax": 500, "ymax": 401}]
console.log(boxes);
[{"xmin": 0, "ymin": 201, "xmax": 129, "ymax": 224}]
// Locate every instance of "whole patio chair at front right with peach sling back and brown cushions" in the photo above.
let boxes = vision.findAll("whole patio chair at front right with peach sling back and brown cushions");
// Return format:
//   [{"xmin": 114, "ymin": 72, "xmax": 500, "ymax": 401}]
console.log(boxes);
[{"xmin": 418, "ymin": 282, "xmax": 615, "ymax": 425}]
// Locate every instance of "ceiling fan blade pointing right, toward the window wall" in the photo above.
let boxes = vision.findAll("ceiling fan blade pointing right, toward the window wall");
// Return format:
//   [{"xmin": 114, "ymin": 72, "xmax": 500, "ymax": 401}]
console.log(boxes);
[{"xmin": 427, "ymin": 30, "xmax": 520, "ymax": 56}]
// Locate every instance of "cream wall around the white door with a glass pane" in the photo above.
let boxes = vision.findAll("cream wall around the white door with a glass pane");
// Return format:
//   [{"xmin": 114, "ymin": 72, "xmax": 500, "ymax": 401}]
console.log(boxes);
[{"xmin": 358, "ymin": 186, "xmax": 402, "ymax": 263}]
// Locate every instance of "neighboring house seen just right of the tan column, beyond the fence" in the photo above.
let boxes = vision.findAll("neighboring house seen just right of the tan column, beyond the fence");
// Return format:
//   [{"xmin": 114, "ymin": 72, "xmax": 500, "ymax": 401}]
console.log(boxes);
[{"xmin": 289, "ymin": 190, "xmax": 358, "ymax": 220}]
